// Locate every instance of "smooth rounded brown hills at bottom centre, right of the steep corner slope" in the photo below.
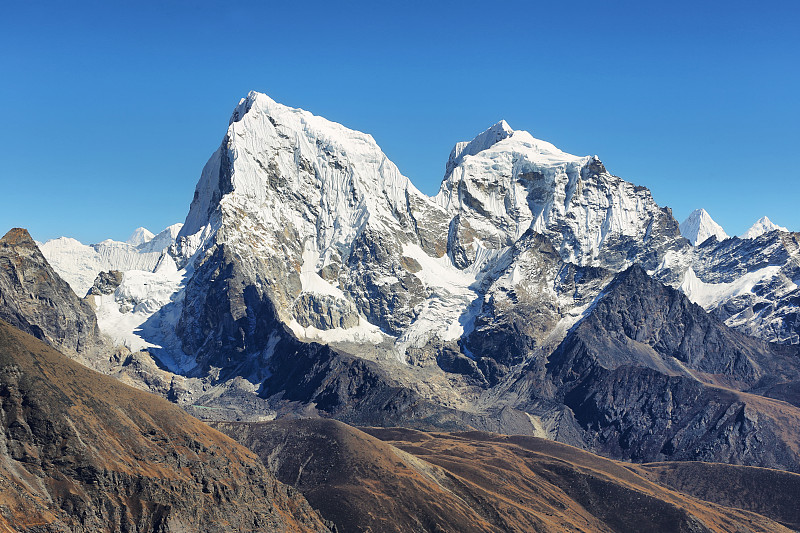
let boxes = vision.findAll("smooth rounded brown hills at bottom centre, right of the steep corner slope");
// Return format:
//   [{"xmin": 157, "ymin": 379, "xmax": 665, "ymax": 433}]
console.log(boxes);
[{"xmin": 217, "ymin": 420, "xmax": 799, "ymax": 533}]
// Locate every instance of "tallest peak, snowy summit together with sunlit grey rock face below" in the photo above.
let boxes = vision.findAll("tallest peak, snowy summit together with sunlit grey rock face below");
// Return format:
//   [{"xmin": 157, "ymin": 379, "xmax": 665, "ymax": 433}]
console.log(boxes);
[{"xmin": 173, "ymin": 93, "xmax": 454, "ymax": 354}]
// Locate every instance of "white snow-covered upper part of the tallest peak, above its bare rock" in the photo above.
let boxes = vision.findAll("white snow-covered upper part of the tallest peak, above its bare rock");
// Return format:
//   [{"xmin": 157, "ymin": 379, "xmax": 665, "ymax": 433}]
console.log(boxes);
[{"xmin": 180, "ymin": 87, "xmax": 437, "ymax": 266}]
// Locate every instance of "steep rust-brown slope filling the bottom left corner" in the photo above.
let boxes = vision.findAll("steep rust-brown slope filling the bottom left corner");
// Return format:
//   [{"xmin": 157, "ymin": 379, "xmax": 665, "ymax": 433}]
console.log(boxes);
[{"xmin": 0, "ymin": 321, "xmax": 328, "ymax": 532}]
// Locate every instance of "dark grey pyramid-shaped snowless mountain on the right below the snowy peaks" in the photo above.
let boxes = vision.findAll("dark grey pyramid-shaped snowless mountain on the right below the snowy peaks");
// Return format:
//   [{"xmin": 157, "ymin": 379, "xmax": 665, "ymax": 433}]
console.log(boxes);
[{"xmin": 536, "ymin": 266, "xmax": 800, "ymax": 471}]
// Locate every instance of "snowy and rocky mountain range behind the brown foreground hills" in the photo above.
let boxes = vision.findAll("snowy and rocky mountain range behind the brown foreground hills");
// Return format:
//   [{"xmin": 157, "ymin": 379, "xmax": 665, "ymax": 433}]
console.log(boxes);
[{"xmin": 0, "ymin": 92, "xmax": 800, "ymax": 530}]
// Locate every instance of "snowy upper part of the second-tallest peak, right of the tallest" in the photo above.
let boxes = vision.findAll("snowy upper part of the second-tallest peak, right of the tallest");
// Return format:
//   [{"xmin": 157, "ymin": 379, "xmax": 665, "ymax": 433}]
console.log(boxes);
[{"xmin": 435, "ymin": 123, "xmax": 681, "ymax": 270}]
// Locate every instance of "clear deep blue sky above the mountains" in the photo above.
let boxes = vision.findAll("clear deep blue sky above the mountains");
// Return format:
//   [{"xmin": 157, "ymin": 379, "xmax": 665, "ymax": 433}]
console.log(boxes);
[{"xmin": 0, "ymin": 0, "xmax": 800, "ymax": 242}]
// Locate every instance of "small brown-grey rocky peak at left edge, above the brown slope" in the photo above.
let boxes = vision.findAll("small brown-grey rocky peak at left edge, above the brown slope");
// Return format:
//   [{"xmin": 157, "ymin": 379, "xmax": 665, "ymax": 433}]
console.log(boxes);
[{"xmin": 0, "ymin": 228, "xmax": 100, "ymax": 357}]
